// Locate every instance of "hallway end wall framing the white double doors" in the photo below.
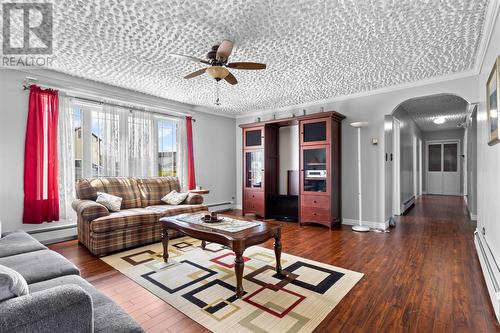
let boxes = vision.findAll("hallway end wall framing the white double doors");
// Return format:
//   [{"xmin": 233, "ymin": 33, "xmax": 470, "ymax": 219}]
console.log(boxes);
[{"xmin": 422, "ymin": 128, "xmax": 465, "ymax": 193}]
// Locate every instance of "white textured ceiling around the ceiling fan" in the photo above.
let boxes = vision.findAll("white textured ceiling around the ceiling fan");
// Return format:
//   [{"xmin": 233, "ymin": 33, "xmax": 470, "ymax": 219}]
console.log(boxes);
[{"xmin": 22, "ymin": 0, "xmax": 487, "ymax": 115}]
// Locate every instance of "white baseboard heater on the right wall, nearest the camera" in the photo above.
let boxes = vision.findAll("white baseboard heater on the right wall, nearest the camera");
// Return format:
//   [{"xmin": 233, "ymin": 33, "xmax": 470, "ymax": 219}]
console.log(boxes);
[{"xmin": 474, "ymin": 230, "xmax": 500, "ymax": 322}]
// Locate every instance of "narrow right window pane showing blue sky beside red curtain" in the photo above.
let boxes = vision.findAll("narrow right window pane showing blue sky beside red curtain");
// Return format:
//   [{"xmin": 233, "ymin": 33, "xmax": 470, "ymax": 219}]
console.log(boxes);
[{"xmin": 156, "ymin": 118, "xmax": 177, "ymax": 177}]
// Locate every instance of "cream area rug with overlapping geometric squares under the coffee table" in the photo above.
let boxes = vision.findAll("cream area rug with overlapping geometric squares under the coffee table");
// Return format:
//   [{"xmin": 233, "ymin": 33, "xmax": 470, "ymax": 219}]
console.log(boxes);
[{"xmin": 101, "ymin": 237, "xmax": 363, "ymax": 333}]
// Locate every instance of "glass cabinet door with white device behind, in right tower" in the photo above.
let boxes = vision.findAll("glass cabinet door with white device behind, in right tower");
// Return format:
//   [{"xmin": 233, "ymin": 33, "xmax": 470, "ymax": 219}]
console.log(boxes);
[{"xmin": 301, "ymin": 146, "xmax": 330, "ymax": 194}]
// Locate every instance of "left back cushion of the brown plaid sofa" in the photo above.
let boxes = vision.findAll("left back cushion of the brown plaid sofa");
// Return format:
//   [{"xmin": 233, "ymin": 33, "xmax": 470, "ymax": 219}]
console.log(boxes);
[{"xmin": 76, "ymin": 177, "xmax": 141, "ymax": 209}]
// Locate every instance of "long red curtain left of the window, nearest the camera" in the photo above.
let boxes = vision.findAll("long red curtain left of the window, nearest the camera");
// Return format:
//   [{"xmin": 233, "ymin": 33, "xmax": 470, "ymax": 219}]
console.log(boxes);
[{"xmin": 23, "ymin": 85, "xmax": 59, "ymax": 224}]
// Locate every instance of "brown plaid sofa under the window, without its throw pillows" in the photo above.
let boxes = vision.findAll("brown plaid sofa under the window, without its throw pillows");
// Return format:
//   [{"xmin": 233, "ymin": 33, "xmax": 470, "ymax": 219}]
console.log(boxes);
[{"xmin": 72, "ymin": 177, "xmax": 207, "ymax": 256}]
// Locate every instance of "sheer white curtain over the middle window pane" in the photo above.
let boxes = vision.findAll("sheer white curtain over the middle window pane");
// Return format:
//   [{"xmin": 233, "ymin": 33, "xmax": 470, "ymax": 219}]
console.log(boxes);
[{"xmin": 127, "ymin": 111, "xmax": 154, "ymax": 177}]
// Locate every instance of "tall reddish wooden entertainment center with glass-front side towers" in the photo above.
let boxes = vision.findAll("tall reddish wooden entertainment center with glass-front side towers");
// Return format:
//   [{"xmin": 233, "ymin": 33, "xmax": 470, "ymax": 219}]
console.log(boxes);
[{"xmin": 240, "ymin": 111, "xmax": 345, "ymax": 228}]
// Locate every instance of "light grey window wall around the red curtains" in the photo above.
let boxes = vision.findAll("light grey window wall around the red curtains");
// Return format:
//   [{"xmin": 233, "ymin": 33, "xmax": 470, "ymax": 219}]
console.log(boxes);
[{"xmin": 0, "ymin": 69, "xmax": 236, "ymax": 240}]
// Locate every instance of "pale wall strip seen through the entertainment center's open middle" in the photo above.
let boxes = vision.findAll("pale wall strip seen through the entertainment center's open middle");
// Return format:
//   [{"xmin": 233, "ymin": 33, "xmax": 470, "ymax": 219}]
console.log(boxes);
[{"xmin": 278, "ymin": 125, "xmax": 300, "ymax": 194}]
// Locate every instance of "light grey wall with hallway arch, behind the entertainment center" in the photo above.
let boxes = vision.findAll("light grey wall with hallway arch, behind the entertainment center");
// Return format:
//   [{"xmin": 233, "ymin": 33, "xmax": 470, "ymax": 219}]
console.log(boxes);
[{"xmin": 236, "ymin": 76, "xmax": 478, "ymax": 223}]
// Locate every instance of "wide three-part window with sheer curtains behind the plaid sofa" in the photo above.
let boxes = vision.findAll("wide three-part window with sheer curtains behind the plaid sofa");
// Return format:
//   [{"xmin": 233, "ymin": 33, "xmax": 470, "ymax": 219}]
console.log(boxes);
[{"xmin": 72, "ymin": 101, "xmax": 178, "ymax": 179}]
